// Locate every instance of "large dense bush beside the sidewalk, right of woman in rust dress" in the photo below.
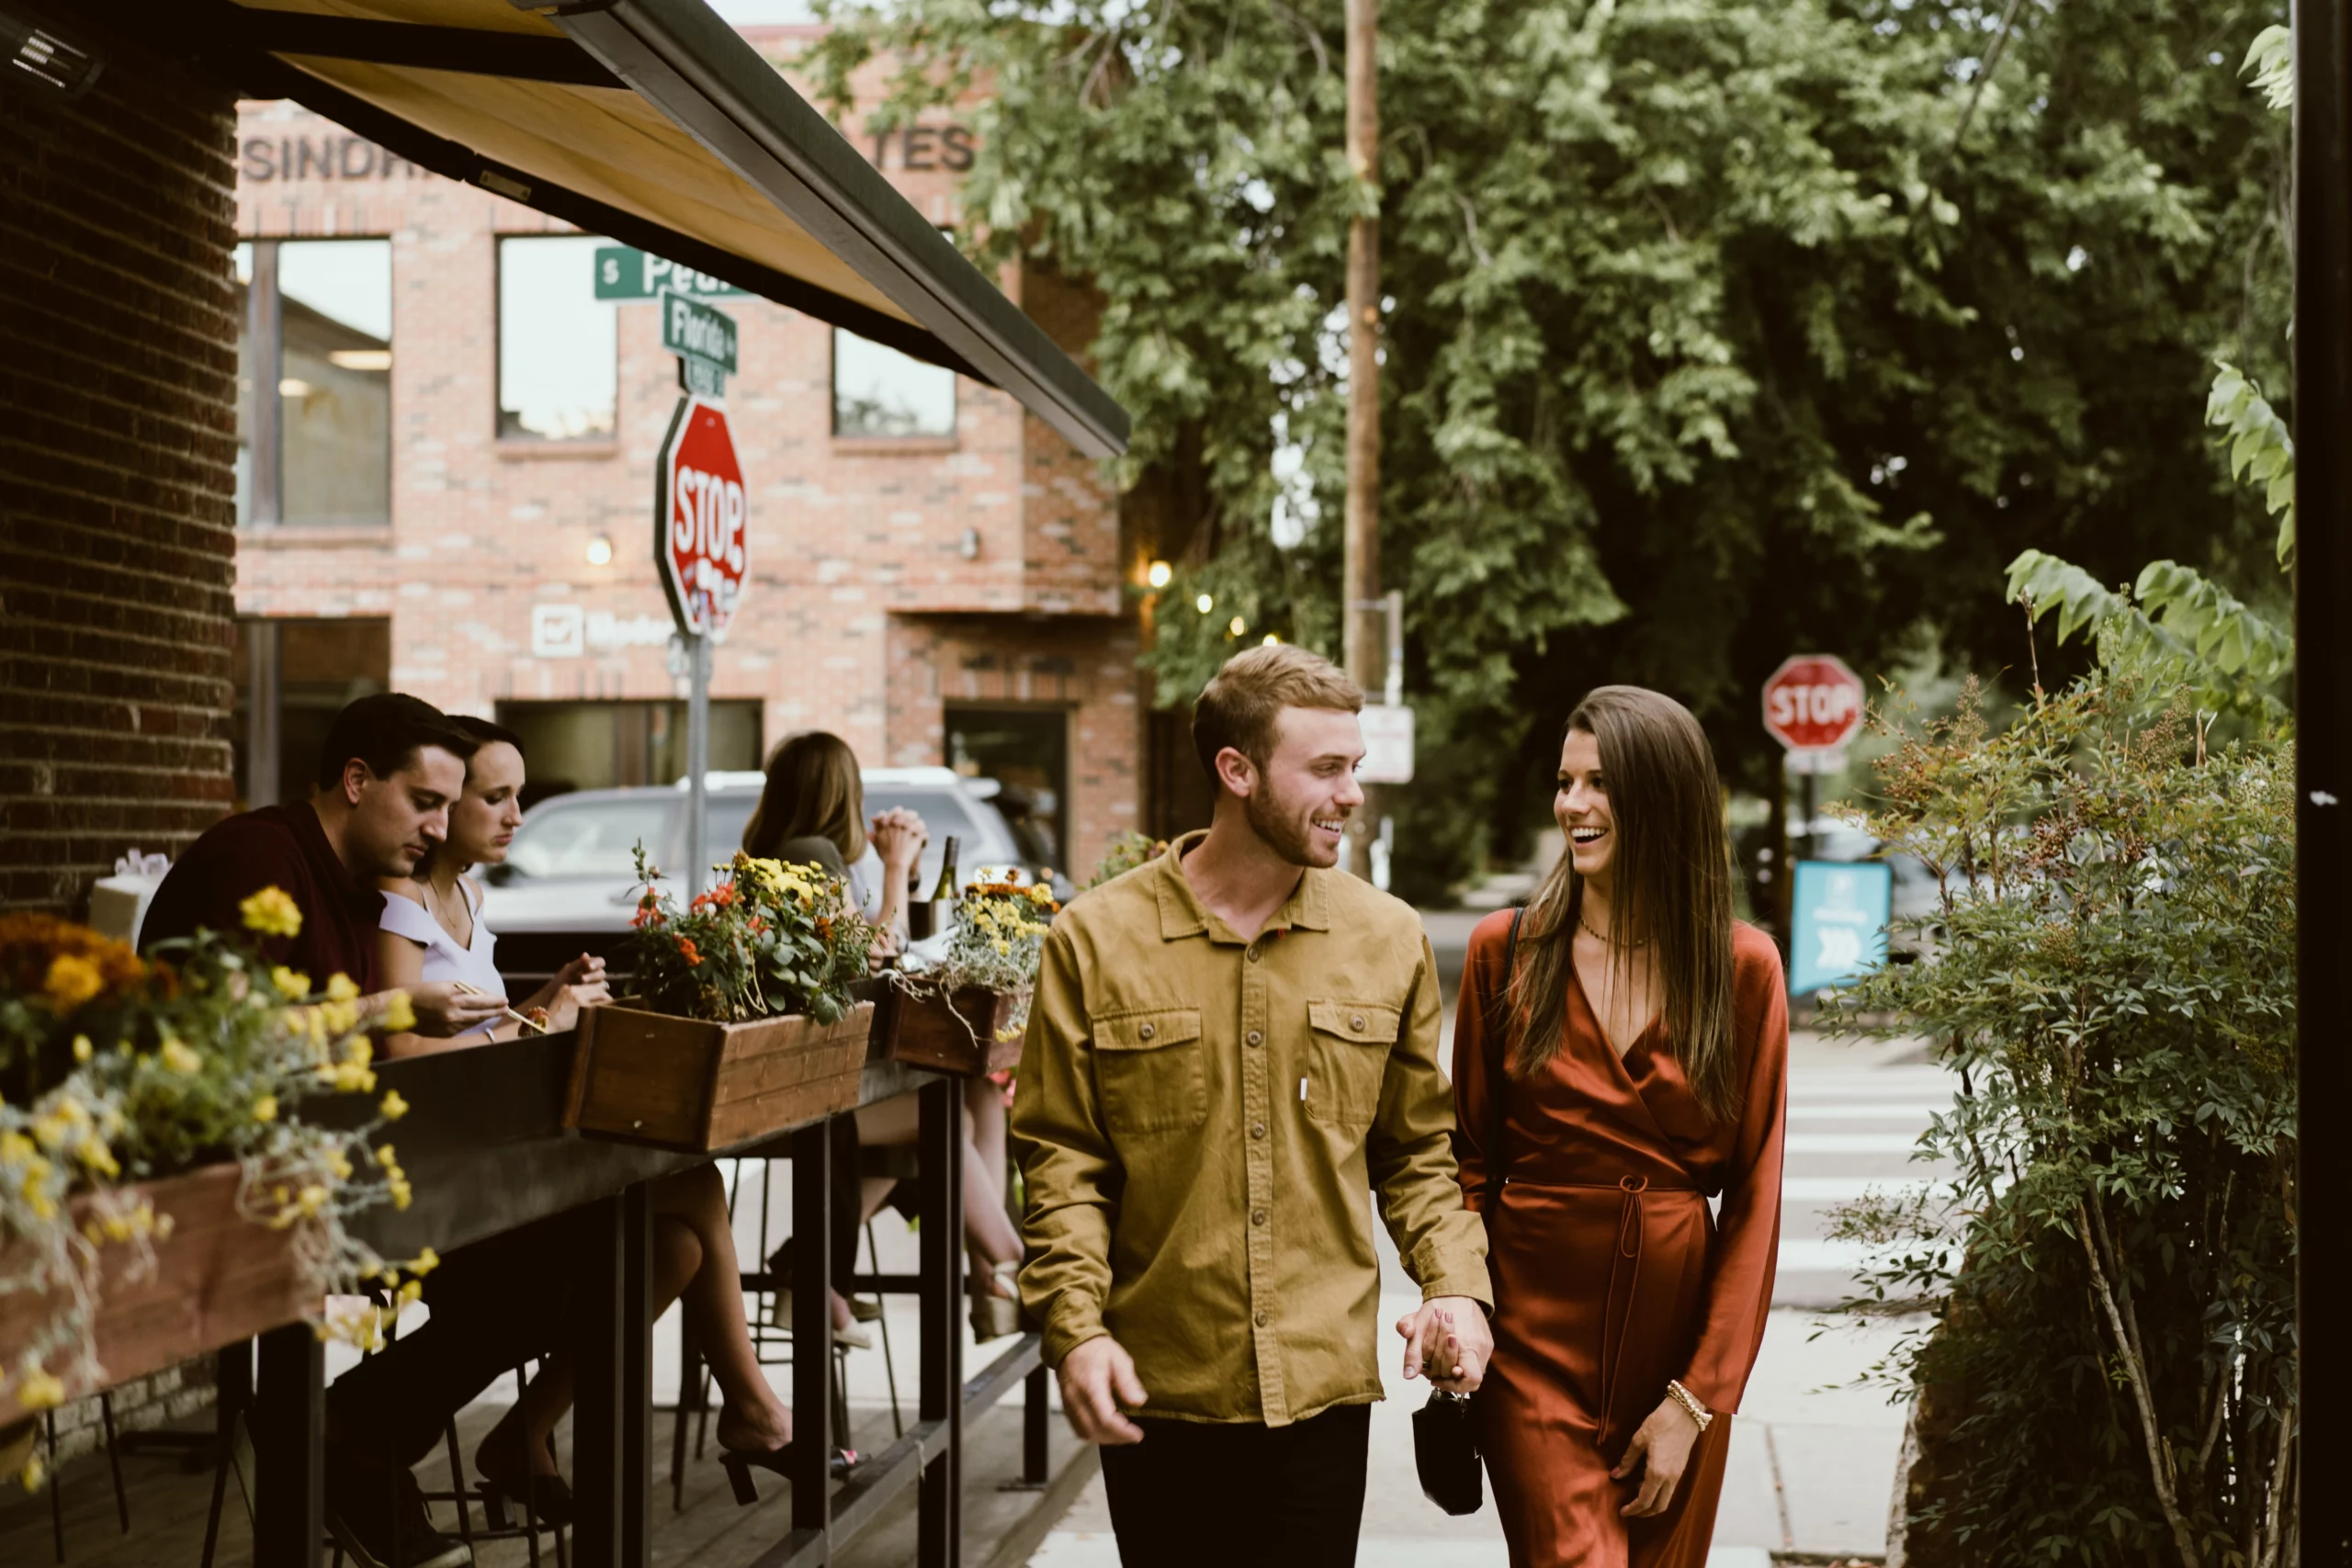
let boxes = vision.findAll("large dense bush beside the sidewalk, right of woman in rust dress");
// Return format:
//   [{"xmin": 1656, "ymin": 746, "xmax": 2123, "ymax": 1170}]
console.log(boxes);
[{"xmin": 1835, "ymin": 677, "xmax": 2298, "ymax": 1568}]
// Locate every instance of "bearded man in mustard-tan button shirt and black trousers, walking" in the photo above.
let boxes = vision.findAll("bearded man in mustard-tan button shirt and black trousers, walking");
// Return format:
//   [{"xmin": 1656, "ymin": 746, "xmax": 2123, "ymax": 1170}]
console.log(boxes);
[{"xmin": 1012, "ymin": 644, "xmax": 1494, "ymax": 1568}]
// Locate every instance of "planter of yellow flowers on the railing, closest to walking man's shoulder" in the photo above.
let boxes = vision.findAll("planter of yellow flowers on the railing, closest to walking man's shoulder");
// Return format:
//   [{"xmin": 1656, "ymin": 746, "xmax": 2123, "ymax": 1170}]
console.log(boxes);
[{"xmin": 877, "ymin": 872, "xmax": 1061, "ymax": 1077}]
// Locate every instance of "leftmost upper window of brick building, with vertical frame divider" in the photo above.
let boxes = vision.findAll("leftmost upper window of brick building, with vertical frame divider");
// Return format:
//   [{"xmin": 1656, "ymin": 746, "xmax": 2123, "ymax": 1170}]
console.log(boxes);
[{"xmin": 238, "ymin": 240, "xmax": 393, "ymax": 526}]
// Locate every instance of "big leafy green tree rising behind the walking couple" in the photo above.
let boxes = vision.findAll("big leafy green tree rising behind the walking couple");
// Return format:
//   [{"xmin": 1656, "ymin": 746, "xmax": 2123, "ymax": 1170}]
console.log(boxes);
[{"xmin": 814, "ymin": 0, "xmax": 2286, "ymax": 894}]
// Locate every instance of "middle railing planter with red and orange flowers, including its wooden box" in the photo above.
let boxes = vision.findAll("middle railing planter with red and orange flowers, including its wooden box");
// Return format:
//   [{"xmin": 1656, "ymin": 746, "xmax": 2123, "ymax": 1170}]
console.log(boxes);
[{"xmin": 564, "ymin": 846, "xmax": 873, "ymax": 1152}]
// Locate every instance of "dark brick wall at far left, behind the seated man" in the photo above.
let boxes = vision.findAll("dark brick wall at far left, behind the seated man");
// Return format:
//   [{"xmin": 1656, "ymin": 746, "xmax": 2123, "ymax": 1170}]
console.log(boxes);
[{"xmin": 0, "ymin": 56, "xmax": 238, "ymax": 915}]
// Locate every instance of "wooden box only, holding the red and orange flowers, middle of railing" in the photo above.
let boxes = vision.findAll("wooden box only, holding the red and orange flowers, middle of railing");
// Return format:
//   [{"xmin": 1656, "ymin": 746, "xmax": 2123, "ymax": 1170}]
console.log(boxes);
[{"xmin": 564, "ymin": 1001, "xmax": 875, "ymax": 1155}]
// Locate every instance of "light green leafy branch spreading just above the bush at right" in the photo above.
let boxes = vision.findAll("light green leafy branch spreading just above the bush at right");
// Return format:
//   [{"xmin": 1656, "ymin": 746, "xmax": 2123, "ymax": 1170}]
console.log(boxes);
[{"xmin": 2008, "ymin": 550, "xmax": 2296, "ymax": 717}]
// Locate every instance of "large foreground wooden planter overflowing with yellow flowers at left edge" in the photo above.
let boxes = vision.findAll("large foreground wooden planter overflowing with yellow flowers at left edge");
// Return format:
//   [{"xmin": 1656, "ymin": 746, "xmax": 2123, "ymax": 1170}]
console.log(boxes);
[{"xmin": 0, "ymin": 888, "xmax": 435, "ymax": 1485}]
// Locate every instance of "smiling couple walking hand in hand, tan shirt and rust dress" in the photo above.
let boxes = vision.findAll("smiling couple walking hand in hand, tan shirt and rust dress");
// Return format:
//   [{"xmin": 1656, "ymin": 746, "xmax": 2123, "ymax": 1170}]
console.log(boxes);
[{"xmin": 1012, "ymin": 644, "xmax": 1788, "ymax": 1568}]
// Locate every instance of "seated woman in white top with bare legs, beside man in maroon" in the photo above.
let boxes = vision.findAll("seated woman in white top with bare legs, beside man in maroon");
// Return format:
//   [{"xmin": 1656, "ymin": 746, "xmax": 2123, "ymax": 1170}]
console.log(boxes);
[{"xmin": 377, "ymin": 715, "xmax": 793, "ymax": 1523}]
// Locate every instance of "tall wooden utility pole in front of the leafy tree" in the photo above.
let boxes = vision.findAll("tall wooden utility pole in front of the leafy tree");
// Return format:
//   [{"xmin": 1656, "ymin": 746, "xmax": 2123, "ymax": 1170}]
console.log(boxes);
[{"xmin": 1340, "ymin": 0, "xmax": 1383, "ymax": 877}]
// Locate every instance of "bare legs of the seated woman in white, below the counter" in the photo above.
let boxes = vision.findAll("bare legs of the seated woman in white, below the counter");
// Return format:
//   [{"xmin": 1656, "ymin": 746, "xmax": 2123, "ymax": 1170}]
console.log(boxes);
[{"xmin": 475, "ymin": 1166, "xmax": 793, "ymax": 1474}]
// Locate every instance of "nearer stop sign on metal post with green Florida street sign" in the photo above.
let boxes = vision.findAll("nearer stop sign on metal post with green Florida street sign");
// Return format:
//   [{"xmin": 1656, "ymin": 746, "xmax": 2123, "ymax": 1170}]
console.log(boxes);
[{"xmin": 654, "ymin": 294, "xmax": 751, "ymax": 898}]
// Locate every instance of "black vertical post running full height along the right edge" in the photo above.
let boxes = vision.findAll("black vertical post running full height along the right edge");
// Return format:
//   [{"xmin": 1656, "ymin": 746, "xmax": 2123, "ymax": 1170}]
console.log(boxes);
[{"xmin": 2293, "ymin": 0, "xmax": 2352, "ymax": 1568}]
